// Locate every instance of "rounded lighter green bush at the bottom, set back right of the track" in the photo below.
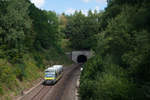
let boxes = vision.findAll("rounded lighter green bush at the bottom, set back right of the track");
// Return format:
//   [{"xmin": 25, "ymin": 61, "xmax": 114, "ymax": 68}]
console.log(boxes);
[{"xmin": 93, "ymin": 69, "xmax": 132, "ymax": 100}]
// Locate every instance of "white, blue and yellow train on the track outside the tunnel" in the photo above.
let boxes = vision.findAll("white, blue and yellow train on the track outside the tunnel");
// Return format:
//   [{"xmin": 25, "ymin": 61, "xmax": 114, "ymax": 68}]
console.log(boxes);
[{"xmin": 44, "ymin": 65, "xmax": 63, "ymax": 84}]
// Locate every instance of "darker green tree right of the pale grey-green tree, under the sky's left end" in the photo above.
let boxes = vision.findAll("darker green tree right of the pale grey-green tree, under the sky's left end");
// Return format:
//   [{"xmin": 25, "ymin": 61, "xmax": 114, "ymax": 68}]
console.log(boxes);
[{"xmin": 29, "ymin": 5, "xmax": 60, "ymax": 50}]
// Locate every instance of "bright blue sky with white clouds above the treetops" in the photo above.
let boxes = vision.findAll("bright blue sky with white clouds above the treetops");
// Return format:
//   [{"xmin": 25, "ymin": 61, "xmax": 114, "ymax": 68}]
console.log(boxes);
[{"xmin": 31, "ymin": 0, "xmax": 107, "ymax": 15}]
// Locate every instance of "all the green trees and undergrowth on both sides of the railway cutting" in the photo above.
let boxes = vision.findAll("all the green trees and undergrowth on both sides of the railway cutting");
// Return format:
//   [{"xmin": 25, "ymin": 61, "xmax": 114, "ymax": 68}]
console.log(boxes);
[{"xmin": 0, "ymin": 0, "xmax": 150, "ymax": 100}]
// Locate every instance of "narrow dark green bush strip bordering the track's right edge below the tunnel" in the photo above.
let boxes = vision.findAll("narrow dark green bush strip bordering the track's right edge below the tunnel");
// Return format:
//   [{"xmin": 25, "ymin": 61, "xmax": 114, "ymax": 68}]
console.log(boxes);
[{"xmin": 79, "ymin": 57, "xmax": 102, "ymax": 100}]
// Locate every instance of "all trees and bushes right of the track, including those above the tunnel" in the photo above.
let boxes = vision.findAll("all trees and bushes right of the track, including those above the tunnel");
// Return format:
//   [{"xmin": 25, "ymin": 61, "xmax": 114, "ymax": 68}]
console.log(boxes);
[{"xmin": 59, "ymin": 0, "xmax": 150, "ymax": 100}]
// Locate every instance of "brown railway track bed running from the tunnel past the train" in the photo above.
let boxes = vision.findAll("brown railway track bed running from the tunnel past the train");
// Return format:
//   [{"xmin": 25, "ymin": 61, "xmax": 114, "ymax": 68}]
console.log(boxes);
[{"xmin": 21, "ymin": 64, "xmax": 80, "ymax": 100}]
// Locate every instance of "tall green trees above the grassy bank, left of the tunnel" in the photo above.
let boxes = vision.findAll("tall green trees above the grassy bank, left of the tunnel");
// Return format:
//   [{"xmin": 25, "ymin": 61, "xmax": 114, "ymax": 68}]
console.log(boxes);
[{"xmin": 0, "ymin": 0, "xmax": 62, "ymax": 63}]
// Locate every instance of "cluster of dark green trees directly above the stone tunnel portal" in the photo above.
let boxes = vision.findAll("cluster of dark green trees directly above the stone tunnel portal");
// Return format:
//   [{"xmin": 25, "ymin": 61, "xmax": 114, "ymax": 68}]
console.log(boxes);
[{"xmin": 65, "ymin": 11, "xmax": 99, "ymax": 50}]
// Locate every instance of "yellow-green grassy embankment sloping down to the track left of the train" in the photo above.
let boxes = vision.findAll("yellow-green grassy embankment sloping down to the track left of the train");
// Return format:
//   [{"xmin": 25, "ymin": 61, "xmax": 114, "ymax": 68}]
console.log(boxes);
[{"xmin": 0, "ymin": 49, "xmax": 72, "ymax": 100}]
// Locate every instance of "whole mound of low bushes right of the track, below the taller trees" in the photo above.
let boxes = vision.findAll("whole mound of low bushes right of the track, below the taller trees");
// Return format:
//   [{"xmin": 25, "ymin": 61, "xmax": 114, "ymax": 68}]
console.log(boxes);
[{"xmin": 79, "ymin": 56, "xmax": 136, "ymax": 100}]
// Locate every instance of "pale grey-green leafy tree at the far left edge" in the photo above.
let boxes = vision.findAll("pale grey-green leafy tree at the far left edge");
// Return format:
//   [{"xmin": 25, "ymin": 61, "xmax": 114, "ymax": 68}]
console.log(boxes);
[{"xmin": 0, "ymin": 0, "xmax": 31, "ymax": 62}]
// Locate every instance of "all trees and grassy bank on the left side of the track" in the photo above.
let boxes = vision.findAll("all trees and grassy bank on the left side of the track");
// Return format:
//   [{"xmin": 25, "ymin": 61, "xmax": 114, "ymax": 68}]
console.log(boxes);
[{"xmin": 0, "ymin": 0, "xmax": 69, "ymax": 99}]
